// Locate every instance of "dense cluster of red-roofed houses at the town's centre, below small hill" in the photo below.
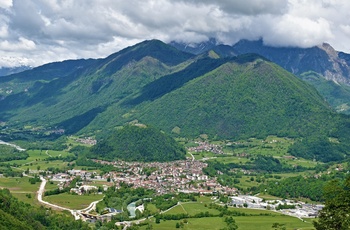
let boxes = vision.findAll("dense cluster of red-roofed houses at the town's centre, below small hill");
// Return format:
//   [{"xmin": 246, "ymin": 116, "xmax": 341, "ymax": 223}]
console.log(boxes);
[{"xmin": 96, "ymin": 160, "xmax": 236, "ymax": 194}]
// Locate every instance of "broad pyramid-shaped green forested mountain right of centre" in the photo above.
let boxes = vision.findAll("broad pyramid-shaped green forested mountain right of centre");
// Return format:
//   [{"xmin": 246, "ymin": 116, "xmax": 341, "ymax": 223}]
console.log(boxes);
[{"xmin": 136, "ymin": 55, "xmax": 332, "ymax": 139}]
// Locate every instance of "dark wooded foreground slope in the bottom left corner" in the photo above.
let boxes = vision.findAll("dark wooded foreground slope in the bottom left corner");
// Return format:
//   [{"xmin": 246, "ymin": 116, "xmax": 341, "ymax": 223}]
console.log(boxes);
[{"xmin": 0, "ymin": 189, "xmax": 90, "ymax": 230}]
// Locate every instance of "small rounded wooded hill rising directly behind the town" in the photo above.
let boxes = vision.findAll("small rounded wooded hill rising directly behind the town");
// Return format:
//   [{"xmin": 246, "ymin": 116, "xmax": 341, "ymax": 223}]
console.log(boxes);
[{"xmin": 88, "ymin": 125, "xmax": 186, "ymax": 162}]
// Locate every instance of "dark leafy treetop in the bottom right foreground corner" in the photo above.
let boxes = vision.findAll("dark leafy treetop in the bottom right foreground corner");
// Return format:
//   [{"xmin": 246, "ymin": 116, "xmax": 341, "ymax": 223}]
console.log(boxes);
[{"xmin": 314, "ymin": 177, "xmax": 350, "ymax": 230}]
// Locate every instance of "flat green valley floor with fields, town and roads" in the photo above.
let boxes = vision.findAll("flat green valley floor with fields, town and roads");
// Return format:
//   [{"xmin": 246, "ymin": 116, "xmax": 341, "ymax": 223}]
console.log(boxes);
[{"xmin": 0, "ymin": 136, "xmax": 346, "ymax": 229}]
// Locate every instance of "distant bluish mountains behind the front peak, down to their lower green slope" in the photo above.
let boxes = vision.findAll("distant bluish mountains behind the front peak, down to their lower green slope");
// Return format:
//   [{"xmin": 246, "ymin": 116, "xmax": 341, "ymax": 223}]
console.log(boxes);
[{"xmin": 170, "ymin": 39, "xmax": 350, "ymax": 114}]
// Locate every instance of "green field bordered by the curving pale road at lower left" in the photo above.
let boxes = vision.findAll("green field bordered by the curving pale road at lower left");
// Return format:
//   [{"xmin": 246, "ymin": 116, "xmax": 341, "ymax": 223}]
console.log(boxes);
[{"xmin": 44, "ymin": 193, "xmax": 103, "ymax": 210}]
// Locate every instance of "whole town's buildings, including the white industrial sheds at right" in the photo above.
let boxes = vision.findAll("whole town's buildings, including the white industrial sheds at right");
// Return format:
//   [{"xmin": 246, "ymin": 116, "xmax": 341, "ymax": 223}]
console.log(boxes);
[{"xmin": 42, "ymin": 158, "xmax": 323, "ymax": 221}]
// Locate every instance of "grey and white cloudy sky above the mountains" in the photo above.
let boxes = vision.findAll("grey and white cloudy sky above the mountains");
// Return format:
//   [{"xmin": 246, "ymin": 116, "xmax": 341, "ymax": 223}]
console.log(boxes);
[{"xmin": 0, "ymin": 0, "xmax": 350, "ymax": 66}]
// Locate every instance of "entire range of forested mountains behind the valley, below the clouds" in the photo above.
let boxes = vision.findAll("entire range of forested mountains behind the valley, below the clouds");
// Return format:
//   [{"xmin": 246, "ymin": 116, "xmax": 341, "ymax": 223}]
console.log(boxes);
[{"xmin": 0, "ymin": 40, "xmax": 350, "ymax": 162}]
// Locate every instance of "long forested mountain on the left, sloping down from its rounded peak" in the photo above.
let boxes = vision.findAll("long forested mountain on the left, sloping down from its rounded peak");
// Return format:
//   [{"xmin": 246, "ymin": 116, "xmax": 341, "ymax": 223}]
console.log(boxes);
[{"xmin": 0, "ymin": 40, "xmax": 193, "ymax": 133}]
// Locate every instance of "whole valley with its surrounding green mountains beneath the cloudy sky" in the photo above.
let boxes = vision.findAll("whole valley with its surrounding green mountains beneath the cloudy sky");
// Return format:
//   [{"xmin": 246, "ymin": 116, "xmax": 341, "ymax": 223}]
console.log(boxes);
[{"xmin": 0, "ymin": 40, "xmax": 350, "ymax": 230}]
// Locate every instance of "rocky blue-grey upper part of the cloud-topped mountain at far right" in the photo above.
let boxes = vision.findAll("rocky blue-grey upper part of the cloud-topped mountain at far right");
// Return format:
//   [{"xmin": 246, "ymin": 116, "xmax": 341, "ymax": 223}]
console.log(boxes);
[{"xmin": 233, "ymin": 40, "xmax": 350, "ymax": 85}]
